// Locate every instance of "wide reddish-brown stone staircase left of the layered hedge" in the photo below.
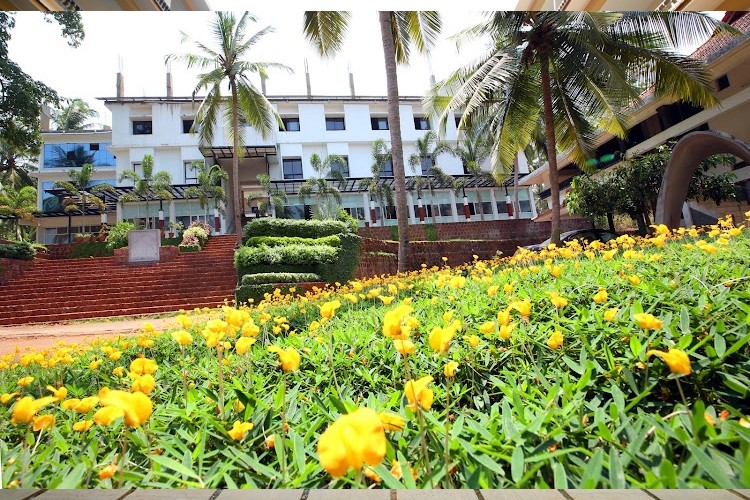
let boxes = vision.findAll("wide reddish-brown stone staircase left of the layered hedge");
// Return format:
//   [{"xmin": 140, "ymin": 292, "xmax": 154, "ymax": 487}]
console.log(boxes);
[{"xmin": 0, "ymin": 235, "xmax": 237, "ymax": 325}]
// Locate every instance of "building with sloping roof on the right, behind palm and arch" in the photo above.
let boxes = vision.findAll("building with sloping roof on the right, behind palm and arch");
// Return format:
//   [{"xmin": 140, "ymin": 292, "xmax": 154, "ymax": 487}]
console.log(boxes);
[{"xmin": 520, "ymin": 13, "xmax": 750, "ymax": 225}]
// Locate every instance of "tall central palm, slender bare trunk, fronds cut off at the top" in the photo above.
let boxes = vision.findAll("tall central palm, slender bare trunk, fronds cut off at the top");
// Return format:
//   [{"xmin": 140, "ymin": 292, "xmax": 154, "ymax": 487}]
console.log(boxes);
[{"xmin": 304, "ymin": 11, "xmax": 442, "ymax": 272}]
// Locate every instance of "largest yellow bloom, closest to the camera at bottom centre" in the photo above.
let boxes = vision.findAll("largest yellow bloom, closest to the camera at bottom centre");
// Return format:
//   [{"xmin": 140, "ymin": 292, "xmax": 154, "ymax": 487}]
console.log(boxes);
[{"xmin": 318, "ymin": 408, "xmax": 386, "ymax": 477}]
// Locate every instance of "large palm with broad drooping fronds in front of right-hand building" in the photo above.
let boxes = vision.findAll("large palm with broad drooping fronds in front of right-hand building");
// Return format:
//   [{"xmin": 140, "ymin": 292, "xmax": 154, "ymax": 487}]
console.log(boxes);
[{"xmin": 427, "ymin": 11, "xmax": 734, "ymax": 243}]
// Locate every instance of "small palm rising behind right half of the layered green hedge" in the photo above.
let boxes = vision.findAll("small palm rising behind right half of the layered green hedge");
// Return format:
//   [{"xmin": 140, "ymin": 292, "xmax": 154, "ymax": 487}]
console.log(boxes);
[{"xmin": 299, "ymin": 153, "xmax": 346, "ymax": 219}]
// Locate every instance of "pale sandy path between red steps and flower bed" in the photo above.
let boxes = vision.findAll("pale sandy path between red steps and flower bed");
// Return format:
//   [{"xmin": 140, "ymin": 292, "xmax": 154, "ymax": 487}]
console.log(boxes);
[{"xmin": 0, "ymin": 317, "xmax": 182, "ymax": 355}]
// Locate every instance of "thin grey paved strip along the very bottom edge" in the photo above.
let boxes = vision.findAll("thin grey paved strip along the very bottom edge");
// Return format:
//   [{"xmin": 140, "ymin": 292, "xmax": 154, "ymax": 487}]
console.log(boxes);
[{"xmin": 0, "ymin": 489, "xmax": 750, "ymax": 500}]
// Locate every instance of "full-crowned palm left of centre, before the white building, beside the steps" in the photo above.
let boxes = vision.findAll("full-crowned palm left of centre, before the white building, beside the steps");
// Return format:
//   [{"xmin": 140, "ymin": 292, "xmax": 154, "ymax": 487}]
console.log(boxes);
[{"xmin": 167, "ymin": 12, "xmax": 292, "ymax": 246}]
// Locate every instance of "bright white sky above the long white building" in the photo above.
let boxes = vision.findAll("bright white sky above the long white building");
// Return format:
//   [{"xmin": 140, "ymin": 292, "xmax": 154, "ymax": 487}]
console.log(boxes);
[{"xmin": 9, "ymin": 10, "xmax": 494, "ymax": 125}]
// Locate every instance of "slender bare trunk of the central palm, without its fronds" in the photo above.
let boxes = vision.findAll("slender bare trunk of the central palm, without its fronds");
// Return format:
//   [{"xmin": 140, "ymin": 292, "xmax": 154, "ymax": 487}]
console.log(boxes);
[{"xmin": 380, "ymin": 11, "xmax": 409, "ymax": 272}]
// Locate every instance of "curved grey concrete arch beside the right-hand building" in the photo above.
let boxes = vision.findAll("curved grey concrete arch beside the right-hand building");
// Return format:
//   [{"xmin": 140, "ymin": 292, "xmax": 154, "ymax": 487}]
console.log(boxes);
[{"xmin": 654, "ymin": 131, "xmax": 750, "ymax": 229}]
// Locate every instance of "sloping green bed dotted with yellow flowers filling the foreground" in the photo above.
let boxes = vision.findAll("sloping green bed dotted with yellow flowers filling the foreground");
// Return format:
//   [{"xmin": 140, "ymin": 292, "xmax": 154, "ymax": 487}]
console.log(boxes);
[{"xmin": 0, "ymin": 213, "xmax": 750, "ymax": 488}]
